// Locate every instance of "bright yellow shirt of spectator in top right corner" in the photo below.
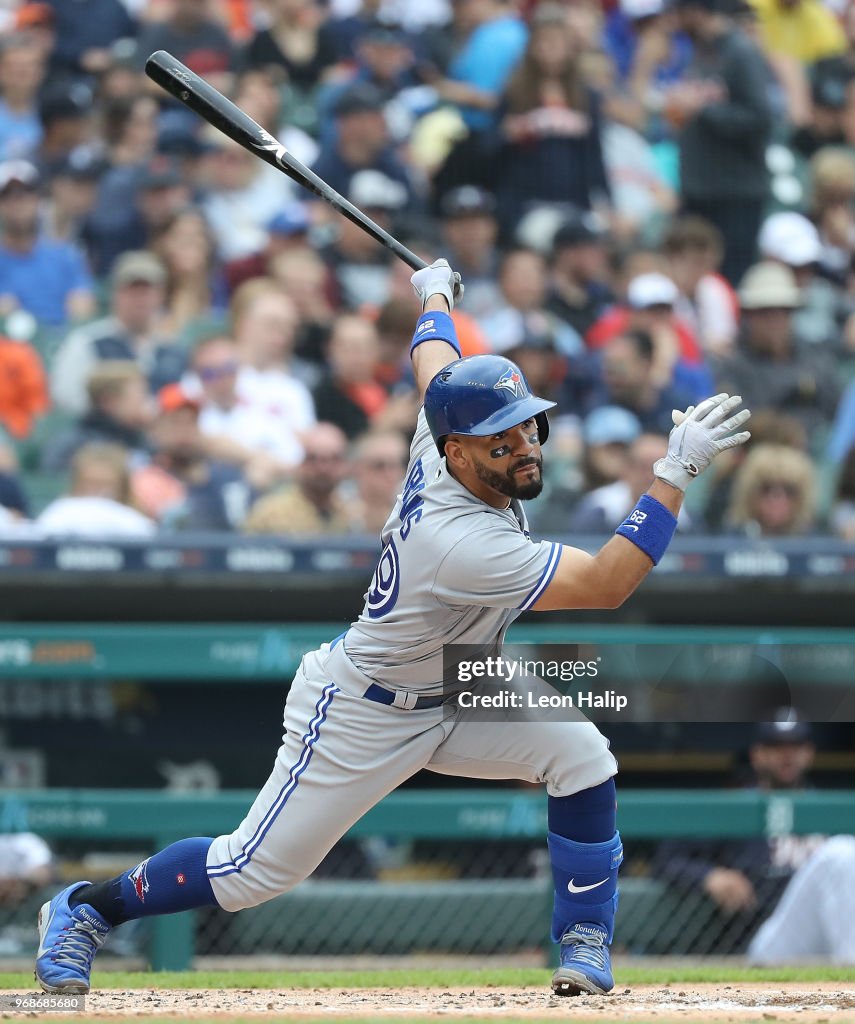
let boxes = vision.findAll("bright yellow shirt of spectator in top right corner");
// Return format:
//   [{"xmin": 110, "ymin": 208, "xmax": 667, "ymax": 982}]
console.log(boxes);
[{"xmin": 752, "ymin": 0, "xmax": 846, "ymax": 63}]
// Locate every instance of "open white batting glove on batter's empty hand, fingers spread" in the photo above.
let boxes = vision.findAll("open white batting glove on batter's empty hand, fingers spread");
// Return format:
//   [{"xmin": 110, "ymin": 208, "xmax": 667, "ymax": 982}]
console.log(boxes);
[{"xmin": 653, "ymin": 394, "xmax": 752, "ymax": 490}]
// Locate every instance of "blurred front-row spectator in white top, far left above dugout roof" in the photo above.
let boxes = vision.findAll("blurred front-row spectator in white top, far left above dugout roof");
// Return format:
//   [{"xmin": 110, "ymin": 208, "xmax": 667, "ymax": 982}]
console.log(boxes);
[{"xmin": 36, "ymin": 443, "xmax": 156, "ymax": 541}]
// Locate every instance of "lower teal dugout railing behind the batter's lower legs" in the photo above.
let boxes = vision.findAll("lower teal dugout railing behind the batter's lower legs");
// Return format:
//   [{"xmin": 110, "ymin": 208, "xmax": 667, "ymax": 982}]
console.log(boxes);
[{"xmin": 0, "ymin": 790, "xmax": 855, "ymax": 970}]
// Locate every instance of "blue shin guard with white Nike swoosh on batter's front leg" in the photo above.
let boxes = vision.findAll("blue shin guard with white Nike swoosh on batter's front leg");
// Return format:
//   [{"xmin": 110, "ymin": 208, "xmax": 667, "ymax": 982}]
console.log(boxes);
[{"xmin": 548, "ymin": 831, "xmax": 624, "ymax": 942}]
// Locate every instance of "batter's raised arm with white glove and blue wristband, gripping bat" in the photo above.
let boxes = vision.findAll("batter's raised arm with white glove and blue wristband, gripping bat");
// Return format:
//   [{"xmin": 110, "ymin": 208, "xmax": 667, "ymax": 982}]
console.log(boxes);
[{"xmin": 410, "ymin": 259, "xmax": 463, "ymax": 398}]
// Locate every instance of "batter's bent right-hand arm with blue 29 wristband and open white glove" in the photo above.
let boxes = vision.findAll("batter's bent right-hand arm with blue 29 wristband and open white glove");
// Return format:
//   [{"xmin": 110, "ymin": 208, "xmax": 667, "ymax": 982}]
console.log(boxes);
[{"xmin": 531, "ymin": 394, "xmax": 751, "ymax": 611}]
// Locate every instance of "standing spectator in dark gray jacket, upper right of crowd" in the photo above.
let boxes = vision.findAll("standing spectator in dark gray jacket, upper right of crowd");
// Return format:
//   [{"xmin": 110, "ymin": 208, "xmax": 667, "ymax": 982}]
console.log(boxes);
[{"xmin": 666, "ymin": 0, "xmax": 772, "ymax": 286}]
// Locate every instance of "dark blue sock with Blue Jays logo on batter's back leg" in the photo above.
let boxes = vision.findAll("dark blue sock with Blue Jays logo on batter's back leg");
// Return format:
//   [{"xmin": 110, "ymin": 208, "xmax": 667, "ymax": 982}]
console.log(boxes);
[{"xmin": 70, "ymin": 838, "xmax": 217, "ymax": 925}]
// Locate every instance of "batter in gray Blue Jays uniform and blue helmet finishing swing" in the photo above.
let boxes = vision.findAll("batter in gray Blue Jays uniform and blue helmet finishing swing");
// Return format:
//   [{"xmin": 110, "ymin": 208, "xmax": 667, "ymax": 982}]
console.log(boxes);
[{"xmin": 36, "ymin": 260, "xmax": 749, "ymax": 994}]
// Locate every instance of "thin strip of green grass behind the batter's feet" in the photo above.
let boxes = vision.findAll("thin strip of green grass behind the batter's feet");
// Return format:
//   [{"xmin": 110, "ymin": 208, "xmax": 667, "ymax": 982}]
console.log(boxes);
[{"xmin": 0, "ymin": 962, "xmax": 855, "ymax": 991}]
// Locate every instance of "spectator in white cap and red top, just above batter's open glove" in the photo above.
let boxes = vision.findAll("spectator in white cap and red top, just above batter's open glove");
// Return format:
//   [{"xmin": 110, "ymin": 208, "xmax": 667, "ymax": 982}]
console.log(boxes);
[{"xmin": 585, "ymin": 270, "xmax": 713, "ymax": 405}]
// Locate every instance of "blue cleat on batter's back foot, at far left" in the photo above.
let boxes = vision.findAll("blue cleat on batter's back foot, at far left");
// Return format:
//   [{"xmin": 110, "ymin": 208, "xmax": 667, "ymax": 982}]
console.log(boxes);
[{"xmin": 36, "ymin": 882, "xmax": 110, "ymax": 992}]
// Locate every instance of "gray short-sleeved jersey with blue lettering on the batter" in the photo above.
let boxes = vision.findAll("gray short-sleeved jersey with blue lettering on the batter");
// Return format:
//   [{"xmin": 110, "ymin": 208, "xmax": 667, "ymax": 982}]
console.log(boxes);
[{"xmin": 335, "ymin": 410, "xmax": 561, "ymax": 692}]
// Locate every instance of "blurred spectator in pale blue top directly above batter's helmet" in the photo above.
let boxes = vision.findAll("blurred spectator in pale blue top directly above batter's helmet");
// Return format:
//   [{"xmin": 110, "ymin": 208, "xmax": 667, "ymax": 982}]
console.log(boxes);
[{"xmin": 478, "ymin": 249, "xmax": 585, "ymax": 356}]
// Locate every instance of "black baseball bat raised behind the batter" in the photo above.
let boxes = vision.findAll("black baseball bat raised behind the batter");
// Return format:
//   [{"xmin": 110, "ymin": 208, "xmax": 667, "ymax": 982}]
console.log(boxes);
[{"xmin": 145, "ymin": 50, "xmax": 427, "ymax": 270}]
